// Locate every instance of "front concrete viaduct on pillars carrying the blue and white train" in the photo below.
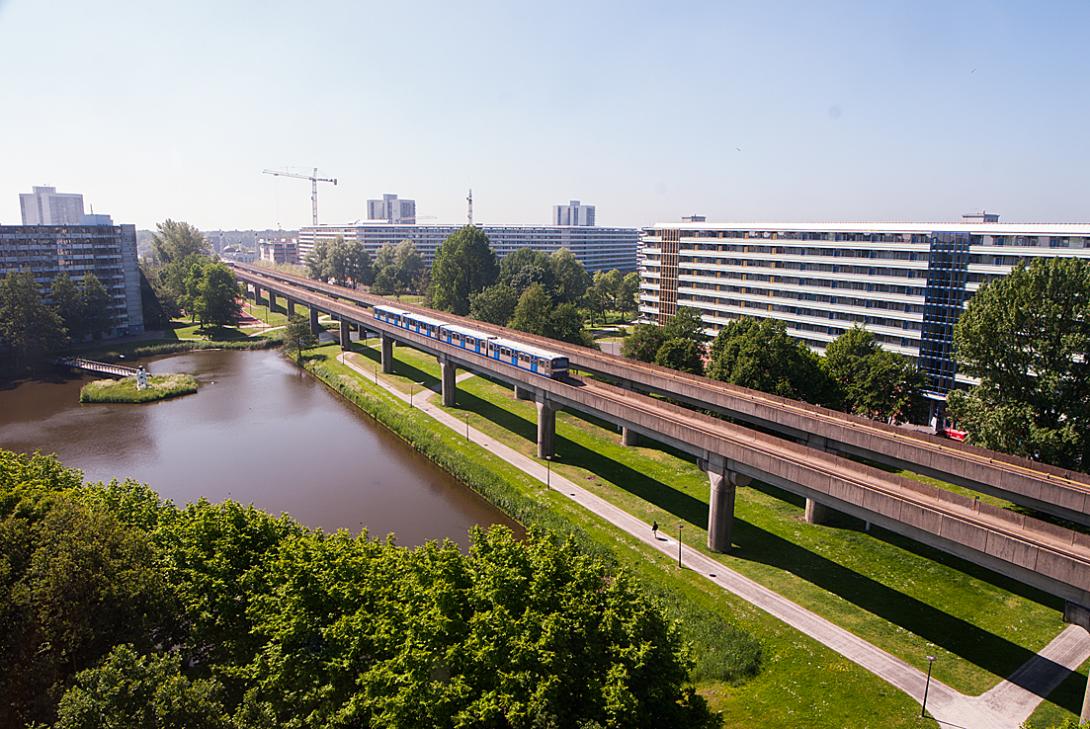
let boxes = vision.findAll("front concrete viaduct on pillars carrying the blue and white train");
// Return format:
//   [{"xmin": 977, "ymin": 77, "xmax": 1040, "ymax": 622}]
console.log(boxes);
[{"xmin": 240, "ymin": 271, "xmax": 1090, "ymax": 624}]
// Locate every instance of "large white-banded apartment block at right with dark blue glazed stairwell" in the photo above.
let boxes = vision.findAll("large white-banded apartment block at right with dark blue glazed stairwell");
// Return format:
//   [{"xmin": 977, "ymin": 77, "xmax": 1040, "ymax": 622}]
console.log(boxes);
[{"xmin": 640, "ymin": 212, "xmax": 1090, "ymax": 399}]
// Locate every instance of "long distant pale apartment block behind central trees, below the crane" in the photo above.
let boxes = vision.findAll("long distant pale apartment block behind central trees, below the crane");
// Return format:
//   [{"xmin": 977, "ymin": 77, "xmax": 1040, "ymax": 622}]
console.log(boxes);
[{"xmin": 299, "ymin": 222, "xmax": 639, "ymax": 272}]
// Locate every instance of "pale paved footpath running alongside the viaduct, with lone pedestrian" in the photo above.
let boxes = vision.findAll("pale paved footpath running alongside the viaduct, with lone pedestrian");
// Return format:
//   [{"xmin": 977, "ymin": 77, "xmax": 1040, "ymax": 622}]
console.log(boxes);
[{"xmin": 340, "ymin": 354, "xmax": 1090, "ymax": 729}]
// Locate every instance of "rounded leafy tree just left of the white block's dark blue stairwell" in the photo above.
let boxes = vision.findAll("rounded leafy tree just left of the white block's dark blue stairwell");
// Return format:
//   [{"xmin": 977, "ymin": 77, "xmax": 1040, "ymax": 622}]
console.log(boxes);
[{"xmin": 821, "ymin": 326, "xmax": 927, "ymax": 420}]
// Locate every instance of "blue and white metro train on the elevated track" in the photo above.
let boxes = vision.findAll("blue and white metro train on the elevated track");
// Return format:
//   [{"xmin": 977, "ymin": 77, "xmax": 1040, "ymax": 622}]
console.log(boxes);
[{"xmin": 373, "ymin": 306, "xmax": 568, "ymax": 379}]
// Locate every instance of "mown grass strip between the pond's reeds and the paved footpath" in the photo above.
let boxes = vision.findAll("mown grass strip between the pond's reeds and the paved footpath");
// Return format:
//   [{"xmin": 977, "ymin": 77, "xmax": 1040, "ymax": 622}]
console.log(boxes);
[{"xmin": 310, "ymin": 345, "xmax": 935, "ymax": 729}]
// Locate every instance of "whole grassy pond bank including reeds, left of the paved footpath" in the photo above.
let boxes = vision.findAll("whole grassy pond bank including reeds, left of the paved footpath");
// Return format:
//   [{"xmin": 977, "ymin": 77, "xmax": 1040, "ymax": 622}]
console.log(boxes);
[{"xmin": 307, "ymin": 347, "xmax": 934, "ymax": 729}]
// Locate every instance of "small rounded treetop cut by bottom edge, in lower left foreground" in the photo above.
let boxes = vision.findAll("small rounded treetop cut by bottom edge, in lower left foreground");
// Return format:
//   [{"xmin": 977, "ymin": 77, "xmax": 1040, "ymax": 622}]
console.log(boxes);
[{"xmin": 53, "ymin": 645, "xmax": 232, "ymax": 729}]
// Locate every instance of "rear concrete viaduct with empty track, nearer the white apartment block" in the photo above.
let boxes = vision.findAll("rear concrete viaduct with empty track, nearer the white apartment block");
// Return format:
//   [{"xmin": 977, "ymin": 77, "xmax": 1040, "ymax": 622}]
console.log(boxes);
[{"xmin": 234, "ymin": 265, "xmax": 1090, "ymax": 525}]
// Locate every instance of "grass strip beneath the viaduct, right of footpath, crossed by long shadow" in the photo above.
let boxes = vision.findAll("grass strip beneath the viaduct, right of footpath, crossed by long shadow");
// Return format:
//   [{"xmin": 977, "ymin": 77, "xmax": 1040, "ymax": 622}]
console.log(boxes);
[{"xmin": 346, "ymin": 339, "xmax": 1080, "ymax": 712}]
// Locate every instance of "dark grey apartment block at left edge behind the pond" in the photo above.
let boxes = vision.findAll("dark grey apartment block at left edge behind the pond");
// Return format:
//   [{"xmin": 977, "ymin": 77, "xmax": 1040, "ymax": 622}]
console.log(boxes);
[{"xmin": 0, "ymin": 222, "xmax": 144, "ymax": 336}]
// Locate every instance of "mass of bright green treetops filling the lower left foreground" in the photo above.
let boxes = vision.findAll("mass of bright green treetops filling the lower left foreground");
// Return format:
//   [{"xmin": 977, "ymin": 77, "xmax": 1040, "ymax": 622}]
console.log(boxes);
[{"xmin": 0, "ymin": 451, "xmax": 717, "ymax": 729}]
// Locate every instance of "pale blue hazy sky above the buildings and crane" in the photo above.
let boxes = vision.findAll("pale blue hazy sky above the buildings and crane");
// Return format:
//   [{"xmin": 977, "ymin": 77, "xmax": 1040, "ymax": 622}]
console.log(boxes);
[{"xmin": 0, "ymin": 0, "xmax": 1090, "ymax": 229}]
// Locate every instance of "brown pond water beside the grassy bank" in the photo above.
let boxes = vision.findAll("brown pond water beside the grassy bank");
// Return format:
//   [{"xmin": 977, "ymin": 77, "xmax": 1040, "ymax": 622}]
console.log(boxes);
[{"xmin": 0, "ymin": 351, "xmax": 521, "ymax": 546}]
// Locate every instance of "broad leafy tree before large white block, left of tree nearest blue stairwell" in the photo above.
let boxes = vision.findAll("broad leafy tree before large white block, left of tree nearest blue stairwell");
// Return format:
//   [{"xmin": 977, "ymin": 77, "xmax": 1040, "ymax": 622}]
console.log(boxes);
[{"xmin": 707, "ymin": 317, "xmax": 836, "ymax": 405}]
